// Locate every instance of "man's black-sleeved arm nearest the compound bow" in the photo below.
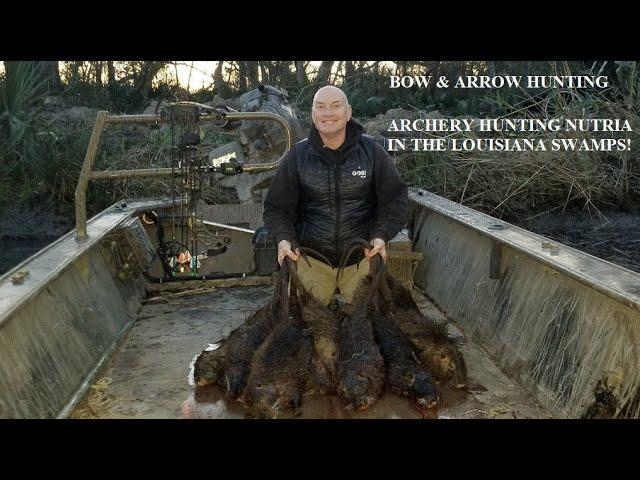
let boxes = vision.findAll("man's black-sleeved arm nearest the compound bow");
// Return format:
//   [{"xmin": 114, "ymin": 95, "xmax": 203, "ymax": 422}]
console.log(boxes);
[{"xmin": 262, "ymin": 149, "xmax": 298, "ymax": 244}]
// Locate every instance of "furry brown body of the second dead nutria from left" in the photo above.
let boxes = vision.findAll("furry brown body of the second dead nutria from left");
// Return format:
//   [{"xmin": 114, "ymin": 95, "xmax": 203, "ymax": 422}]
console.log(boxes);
[{"xmin": 243, "ymin": 316, "xmax": 313, "ymax": 418}]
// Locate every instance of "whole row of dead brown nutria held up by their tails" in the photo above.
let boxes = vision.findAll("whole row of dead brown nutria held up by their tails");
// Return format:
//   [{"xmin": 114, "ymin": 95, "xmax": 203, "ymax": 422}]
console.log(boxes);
[{"xmin": 194, "ymin": 240, "xmax": 467, "ymax": 418}]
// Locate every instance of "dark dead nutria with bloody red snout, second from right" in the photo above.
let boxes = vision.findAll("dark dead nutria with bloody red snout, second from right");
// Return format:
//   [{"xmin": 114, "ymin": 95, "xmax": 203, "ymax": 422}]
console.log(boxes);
[{"xmin": 373, "ymin": 311, "xmax": 437, "ymax": 409}]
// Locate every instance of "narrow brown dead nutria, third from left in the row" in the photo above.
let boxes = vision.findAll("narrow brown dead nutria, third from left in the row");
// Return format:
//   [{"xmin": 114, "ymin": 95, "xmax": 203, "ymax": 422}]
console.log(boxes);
[{"xmin": 285, "ymin": 255, "xmax": 338, "ymax": 394}]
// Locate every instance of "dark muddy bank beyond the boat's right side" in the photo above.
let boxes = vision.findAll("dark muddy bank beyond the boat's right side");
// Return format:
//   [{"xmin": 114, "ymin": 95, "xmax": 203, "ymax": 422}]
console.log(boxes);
[{"xmin": 511, "ymin": 211, "xmax": 640, "ymax": 273}]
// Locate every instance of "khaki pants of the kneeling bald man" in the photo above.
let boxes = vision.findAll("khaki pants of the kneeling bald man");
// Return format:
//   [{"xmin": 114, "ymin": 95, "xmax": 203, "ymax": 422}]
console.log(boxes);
[{"xmin": 296, "ymin": 257, "xmax": 369, "ymax": 305}]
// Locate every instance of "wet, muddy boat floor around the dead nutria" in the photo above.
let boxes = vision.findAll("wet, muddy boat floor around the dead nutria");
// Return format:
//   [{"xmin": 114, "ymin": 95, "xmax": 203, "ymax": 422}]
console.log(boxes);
[{"xmin": 70, "ymin": 285, "xmax": 552, "ymax": 419}]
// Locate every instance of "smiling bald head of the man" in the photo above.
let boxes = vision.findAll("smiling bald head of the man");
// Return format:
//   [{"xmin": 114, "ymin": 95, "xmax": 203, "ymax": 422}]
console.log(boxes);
[{"xmin": 311, "ymin": 85, "xmax": 351, "ymax": 137}]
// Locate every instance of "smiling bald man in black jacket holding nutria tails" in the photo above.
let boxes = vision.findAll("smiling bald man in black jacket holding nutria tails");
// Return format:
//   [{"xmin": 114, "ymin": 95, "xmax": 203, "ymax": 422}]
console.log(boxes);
[{"xmin": 263, "ymin": 86, "xmax": 408, "ymax": 305}]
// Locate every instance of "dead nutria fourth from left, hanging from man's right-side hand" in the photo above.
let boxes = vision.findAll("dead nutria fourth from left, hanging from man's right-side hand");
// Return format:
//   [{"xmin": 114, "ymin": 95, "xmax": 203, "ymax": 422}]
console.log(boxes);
[{"xmin": 338, "ymin": 246, "xmax": 385, "ymax": 410}]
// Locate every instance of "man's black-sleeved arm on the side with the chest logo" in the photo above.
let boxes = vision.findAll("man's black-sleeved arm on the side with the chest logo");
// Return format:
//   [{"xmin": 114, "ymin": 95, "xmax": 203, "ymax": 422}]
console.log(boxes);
[{"xmin": 371, "ymin": 143, "xmax": 409, "ymax": 242}]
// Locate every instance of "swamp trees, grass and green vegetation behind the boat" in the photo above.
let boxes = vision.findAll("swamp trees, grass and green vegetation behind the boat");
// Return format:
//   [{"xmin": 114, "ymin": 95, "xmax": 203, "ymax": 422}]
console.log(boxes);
[{"xmin": 0, "ymin": 61, "xmax": 640, "ymax": 223}]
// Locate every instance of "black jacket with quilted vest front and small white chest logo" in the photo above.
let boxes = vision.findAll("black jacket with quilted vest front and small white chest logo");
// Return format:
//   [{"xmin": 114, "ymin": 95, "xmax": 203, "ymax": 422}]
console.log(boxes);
[{"xmin": 263, "ymin": 120, "xmax": 408, "ymax": 266}]
